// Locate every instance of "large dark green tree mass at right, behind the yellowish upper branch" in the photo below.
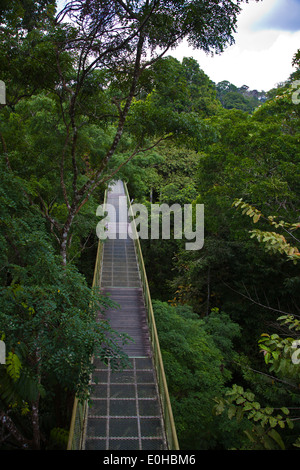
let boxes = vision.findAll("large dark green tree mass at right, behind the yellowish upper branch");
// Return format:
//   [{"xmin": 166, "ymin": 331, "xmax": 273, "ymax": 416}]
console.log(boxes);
[{"xmin": 172, "ymin": 83, "xmax": 299, "ymax": 326}]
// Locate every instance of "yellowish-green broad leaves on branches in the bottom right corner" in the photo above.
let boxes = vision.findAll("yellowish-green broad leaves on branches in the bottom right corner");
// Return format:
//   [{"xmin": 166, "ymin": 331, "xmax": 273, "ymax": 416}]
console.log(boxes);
[{"xmin": 214, "ymin": 315, "xmax": 300, "ymax": 450}]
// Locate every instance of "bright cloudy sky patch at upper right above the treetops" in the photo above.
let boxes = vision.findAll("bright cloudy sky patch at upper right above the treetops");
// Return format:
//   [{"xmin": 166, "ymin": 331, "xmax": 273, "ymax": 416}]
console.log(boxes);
[{"xmin": 171, "ymin": 0, "xmax": 300, "ymax": 91}]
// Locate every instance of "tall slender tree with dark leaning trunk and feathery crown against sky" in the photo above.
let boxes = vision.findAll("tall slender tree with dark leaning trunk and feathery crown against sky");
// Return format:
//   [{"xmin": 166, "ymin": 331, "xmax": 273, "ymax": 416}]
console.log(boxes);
[{"xmin": 52, "ymin": 0, "xmax": 246, "ymax": 260}]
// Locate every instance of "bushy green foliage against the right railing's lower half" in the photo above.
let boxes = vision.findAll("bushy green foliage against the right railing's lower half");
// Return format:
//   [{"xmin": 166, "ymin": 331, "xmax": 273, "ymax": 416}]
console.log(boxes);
[{"xmin": 153, "ymin": 301, "xmax": 243, "ymax": 449}]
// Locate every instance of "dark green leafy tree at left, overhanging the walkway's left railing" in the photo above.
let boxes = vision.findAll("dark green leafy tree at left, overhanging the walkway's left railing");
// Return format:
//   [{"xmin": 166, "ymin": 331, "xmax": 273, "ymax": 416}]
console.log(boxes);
[{"xmin": 0, "ymin": 160, "xmax": 127, "ymax": 449}]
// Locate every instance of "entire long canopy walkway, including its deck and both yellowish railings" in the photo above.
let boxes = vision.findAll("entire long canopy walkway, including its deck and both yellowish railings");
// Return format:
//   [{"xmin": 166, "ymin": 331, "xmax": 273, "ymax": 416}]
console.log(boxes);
[{"xmin": 68, "ymin": 181, "xmax": 178, "ymax": 450}]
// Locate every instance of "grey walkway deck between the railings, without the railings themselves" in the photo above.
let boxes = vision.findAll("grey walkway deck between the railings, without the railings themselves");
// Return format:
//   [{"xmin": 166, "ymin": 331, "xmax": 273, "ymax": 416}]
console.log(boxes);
[{"xmin": 83, "ymin": 181, "xmax": 168, "ymax": 450}]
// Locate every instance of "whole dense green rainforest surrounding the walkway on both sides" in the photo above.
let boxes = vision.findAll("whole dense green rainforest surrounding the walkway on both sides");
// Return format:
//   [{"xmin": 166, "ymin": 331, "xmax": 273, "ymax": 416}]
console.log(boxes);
[{"xmin": 0, "ymin": 0, "xmax": 300, "ymax": 450}]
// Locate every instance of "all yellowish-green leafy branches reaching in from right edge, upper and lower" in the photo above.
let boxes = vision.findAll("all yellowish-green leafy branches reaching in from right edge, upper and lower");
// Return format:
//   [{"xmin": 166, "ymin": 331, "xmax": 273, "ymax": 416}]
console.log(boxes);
[{"xmin": 215, "ymin": 200, "xmax": 300, "ymax": 450}]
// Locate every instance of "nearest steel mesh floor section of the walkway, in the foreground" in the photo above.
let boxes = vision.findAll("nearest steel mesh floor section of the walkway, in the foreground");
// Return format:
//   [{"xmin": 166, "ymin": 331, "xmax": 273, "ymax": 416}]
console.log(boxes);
[{"xmin": 85, "ymin": 357, "xmax": 167, "ymax": 450}]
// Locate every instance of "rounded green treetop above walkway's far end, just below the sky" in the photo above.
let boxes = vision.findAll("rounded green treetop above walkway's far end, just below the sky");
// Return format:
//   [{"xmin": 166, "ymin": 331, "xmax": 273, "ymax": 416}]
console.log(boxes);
[{"xmin": 127, "ymin": 57, "xmax": 219, "ymax": 149}]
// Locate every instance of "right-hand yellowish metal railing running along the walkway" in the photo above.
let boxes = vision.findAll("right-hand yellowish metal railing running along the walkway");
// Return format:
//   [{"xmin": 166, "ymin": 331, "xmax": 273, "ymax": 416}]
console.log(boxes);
[{"xmin": 124, "ymin": 183, "xmax": 179, "ymax": 450}]
